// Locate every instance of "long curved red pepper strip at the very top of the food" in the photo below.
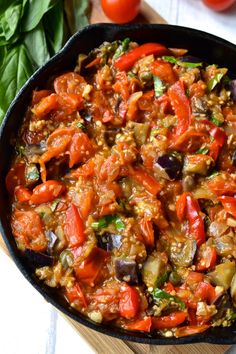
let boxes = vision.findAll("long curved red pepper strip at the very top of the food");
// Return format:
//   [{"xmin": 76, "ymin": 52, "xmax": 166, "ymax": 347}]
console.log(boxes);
[{"xmin": 114, "ymin": 43, "xmax": 169, "ymax": 71}]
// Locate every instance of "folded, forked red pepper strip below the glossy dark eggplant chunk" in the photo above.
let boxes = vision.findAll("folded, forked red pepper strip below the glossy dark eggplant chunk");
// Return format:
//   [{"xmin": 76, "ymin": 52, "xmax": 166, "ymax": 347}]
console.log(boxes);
[{"xmin": 176, "ymin": 192, "xmax": 205, "ymax": 246}]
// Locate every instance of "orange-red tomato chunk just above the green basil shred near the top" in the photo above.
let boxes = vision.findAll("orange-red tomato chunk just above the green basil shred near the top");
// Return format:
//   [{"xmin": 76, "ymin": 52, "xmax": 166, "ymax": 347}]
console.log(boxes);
[{"xmin": 151, "ymin": 60, "xmax": 177, "ymax": 85}]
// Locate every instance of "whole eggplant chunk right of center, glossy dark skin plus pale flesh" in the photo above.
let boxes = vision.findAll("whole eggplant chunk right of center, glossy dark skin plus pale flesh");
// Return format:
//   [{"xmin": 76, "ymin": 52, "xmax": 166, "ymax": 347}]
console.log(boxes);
[{"xmin": 154, "ymin": 154, "xmax": 183, "ymax": 180}]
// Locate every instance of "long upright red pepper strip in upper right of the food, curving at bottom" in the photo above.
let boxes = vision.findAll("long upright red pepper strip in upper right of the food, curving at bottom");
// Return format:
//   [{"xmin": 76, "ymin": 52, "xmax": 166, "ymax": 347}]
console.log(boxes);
[{"xmin": 168, "ymin": 80, "xmax": 192, "ymax": 137}]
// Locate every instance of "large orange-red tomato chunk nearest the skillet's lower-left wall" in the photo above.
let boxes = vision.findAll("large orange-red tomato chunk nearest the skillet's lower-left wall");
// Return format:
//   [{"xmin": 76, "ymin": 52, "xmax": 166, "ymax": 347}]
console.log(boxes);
[{"xmin": 11, "ymin": 210, "xmax": 48, "ymax": 252}]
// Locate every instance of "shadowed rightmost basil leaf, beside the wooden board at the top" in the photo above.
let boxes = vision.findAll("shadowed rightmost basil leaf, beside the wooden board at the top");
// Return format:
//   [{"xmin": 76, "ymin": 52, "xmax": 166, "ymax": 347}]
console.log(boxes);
[{"xmin": 64, "ymin": 0, "xmax": 89, "ymax": 34}]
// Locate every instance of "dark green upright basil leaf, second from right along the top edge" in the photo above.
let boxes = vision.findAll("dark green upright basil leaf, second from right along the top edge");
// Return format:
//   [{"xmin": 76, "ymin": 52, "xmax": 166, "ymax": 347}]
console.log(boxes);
[{"xmin": 43, "ymin": 1, "xmax": 65, "ymax": 56}]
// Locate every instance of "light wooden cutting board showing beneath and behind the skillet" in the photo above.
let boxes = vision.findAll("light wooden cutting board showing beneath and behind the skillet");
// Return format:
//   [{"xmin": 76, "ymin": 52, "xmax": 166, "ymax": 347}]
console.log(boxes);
[{"xmin": 0, "ymin": 0, "xmax": 230, "ymax": 354}]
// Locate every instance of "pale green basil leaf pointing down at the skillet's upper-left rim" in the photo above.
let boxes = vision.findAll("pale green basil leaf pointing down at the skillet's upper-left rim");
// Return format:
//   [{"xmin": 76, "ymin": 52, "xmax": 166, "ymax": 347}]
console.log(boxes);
[{"xmin": 24, "ymin": 22, "xmax": 50, "ymax": 66}]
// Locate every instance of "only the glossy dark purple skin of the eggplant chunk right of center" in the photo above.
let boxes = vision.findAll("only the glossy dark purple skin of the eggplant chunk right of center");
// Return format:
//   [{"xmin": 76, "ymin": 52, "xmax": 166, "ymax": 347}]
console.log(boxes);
[{"xmin": 156, "ymin": 154, "xmax": 183, "ymax": 180}]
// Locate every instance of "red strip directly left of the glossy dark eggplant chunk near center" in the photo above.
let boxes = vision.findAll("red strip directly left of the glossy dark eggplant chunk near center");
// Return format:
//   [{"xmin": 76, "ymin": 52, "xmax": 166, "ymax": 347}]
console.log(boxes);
[{"xmin": 130, "ymin": 168, "xmax": 161, "ymax": 195}]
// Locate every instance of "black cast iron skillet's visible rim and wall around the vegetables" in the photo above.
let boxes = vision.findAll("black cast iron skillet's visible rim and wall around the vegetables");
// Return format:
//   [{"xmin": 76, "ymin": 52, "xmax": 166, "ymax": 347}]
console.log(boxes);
[{"xmin": 0, "ymin": 24, "xmax": 236, "ymax": 345}]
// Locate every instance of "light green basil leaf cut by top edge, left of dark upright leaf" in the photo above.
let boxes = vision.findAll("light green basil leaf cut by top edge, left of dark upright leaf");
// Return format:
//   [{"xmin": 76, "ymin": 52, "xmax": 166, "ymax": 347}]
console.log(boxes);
[{"xmin": 21, "ymin": 0, "xmax": 56, "ymax": 32}]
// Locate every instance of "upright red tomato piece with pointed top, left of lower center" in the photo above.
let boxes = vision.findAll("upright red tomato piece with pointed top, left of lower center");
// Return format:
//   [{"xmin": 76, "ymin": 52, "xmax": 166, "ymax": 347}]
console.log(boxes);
[{"xmin": 64, "ymin": 204, "xmax": 86, "ymax": 247}]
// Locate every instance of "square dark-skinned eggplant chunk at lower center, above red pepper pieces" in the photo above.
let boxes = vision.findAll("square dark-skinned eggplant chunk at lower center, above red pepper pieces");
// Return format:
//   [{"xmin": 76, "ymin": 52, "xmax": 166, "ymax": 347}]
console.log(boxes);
[{"xmin": 114, "ymin": 258, "xmax": 138, "ymax": 285}]
